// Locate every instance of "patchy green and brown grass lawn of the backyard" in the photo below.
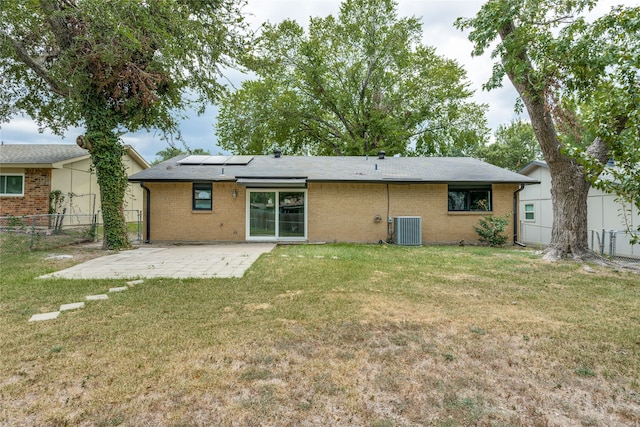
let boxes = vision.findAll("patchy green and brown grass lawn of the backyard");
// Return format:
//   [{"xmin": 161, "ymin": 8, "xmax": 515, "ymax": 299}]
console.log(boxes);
[{"xmin": 0, "ymin": 245, "xmax": 640, "ymax": 427}]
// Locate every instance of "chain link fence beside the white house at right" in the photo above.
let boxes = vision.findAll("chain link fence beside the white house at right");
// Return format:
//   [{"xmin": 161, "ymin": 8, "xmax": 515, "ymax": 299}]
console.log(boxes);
[{"xmin": 519, "ymin": 221, "xmax": 640, "ymax": 262}]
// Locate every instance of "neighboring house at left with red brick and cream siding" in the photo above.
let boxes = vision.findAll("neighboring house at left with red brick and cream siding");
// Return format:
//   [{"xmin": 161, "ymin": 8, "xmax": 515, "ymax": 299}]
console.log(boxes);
[{"xmin": 0, "ymin": 144, "xmax": 149, "ymax": 222}]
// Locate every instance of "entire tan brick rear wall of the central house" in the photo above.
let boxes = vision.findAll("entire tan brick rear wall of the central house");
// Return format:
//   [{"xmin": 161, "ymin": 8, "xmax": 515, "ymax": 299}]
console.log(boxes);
[{"xmin": 144, "ymin": 183, "xmax": 518, "ymax": 244}]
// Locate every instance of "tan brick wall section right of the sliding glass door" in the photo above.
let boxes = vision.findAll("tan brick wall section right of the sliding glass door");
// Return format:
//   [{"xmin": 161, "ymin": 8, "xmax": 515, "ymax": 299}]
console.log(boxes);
[{"xmin": 308, "ymin": 183, "xmax": 518, "ymax": 244}]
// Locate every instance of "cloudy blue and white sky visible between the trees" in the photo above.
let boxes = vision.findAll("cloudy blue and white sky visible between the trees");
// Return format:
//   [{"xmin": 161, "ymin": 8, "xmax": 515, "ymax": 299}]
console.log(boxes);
[{"xmin": 0, "ymin": 0, "xmax": 640, "ymax": 162}]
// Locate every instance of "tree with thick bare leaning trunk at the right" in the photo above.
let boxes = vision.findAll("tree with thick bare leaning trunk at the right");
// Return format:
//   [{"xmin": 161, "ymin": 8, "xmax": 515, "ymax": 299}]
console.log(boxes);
[{"xmin": 457, "ymin": 0, "xmax": 640, "ymax": 259}]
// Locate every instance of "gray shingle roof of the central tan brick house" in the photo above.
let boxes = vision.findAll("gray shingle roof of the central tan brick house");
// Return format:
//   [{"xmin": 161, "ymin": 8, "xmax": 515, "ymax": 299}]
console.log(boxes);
[{"xmin": 129, "ymin": 155, "xmax": 537, "ymax": 184}]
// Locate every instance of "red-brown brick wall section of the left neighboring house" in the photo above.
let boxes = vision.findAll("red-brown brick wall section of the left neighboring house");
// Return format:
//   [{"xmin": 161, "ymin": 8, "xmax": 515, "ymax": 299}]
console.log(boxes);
[{"xmin": 0, "ymin": 169, "xmax": 51, "ymax": 216}]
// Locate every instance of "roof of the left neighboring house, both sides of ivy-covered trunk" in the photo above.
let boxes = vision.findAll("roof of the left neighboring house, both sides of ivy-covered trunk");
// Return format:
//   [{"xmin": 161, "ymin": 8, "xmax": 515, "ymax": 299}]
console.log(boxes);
[{"xmin": 0, "ymin": 144, "xmax": 149, "ymax": 169}]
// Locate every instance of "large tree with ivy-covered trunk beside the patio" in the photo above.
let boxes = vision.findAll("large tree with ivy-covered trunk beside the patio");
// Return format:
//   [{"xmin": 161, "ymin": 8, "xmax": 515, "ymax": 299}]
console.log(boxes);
[{"xmin": 0, "ymin": 0, "xmax": 243, "ymax": 249}]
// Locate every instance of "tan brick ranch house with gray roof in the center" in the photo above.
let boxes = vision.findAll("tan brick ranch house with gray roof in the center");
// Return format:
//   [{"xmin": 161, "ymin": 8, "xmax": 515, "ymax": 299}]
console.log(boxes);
[{"xmin": 129, "ymin": 151, "xmax": 537, "ymax": 244}]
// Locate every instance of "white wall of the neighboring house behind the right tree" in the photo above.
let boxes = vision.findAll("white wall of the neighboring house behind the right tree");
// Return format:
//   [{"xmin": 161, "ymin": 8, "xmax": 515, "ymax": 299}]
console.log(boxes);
[{"xmin": 518, "ymin": 165, "xmax": 640, "ymax": 258}]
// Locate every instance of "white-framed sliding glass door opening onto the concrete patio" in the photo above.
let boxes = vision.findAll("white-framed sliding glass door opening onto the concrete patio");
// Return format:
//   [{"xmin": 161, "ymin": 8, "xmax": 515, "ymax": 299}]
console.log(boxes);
[{"xmin": 247, "ymin": 190, "xmax": 306, "ymax": 240}]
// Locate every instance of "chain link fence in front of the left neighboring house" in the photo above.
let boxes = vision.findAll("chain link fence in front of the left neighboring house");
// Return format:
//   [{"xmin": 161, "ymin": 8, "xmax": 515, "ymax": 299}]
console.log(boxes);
[{"xmin": 0, "ymin": 210, "xmax": 142, "ymax": 254}]
